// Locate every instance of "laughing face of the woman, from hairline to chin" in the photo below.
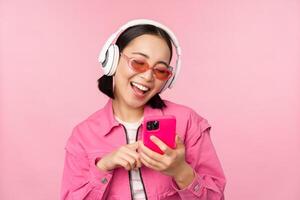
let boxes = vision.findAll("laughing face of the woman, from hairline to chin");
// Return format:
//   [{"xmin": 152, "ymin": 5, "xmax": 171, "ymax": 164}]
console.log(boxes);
[{"xmin": 114, "ymin": 34, "xmax": 170, "ymax": 114}]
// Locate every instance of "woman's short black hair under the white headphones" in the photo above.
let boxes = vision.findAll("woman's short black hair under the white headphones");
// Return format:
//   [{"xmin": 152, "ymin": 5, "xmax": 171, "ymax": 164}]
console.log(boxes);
[{"xmin": 98, "ymin": 24, "xmax": 172, "ymax": 109}]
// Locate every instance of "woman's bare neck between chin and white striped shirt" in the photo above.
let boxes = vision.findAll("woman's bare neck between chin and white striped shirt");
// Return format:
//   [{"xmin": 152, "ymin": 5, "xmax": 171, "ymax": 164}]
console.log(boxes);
[{"xmin": 112, "ymin": 99, "xmax": 144, "ymax": 122}]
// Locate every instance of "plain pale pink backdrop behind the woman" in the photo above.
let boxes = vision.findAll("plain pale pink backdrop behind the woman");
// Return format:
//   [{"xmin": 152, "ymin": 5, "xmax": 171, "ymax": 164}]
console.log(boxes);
[{"xmin": 0, "ymin": 0, "xmax": 300, "ymax": 200}]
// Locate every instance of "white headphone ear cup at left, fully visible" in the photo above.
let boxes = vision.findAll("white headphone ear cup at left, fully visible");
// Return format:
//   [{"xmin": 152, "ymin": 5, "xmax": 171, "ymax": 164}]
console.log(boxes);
[{"xmin": 102, "ymin": 44, "xmax": 119, "ymax": 76}]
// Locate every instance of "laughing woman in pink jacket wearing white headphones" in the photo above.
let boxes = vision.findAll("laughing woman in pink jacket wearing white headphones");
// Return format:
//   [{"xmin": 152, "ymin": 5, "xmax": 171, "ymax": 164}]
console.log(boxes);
[{"xmin": 61, "ymin": 20, "xmax": 226, "ymax": 200}]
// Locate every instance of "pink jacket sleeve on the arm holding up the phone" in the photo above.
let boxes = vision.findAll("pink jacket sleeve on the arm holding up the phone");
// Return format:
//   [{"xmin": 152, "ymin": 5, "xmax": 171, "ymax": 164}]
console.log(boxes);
[{"xmin": 172, "ymin": 111, "xmax": 226, "ymax": 200}]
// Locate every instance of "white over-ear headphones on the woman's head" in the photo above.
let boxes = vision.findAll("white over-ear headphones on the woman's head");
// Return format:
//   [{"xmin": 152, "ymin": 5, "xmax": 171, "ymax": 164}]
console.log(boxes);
[{"xmin": 98, "ymin": 19, "xmax": 181, "ymax": 92}]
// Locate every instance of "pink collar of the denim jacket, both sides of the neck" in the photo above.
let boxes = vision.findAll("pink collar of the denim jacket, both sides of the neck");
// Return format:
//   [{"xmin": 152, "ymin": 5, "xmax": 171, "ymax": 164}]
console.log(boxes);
[{"xmin": 100, "ymin": 99, "xmax": 163, "ymax": 136}]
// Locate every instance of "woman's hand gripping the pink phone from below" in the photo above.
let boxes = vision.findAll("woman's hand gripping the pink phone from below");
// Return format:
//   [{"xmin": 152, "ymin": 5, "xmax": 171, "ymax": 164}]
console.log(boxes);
[{"xmin": 139, "ymin": 135, "xmax": 191, "ymax": 179}]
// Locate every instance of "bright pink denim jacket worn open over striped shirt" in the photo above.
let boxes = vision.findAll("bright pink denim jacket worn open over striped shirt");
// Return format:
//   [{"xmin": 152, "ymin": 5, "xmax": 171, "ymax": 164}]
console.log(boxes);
[{"xmin": 61, "ymin": 100, "xmax": 226, "ymax": 200}]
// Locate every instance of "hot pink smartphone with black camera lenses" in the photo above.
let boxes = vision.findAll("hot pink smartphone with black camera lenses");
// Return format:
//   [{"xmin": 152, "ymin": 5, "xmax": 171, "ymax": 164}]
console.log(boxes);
[{"xmin": 142, "ymin": 115, "xmax": 176, "ymax": 154}]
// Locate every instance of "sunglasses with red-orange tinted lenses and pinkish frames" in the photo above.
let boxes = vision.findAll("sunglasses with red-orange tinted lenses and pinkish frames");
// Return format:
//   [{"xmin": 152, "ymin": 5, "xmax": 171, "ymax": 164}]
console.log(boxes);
[{"xmin": 120, "ymin": 53, "xmax": 173, "ymax": 81}]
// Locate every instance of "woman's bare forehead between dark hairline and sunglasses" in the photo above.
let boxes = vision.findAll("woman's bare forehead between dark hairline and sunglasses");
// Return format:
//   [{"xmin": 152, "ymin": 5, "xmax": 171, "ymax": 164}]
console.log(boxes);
[{"xmin": 124, "ymin": 34, "xmax": 170, "ymax": 62}]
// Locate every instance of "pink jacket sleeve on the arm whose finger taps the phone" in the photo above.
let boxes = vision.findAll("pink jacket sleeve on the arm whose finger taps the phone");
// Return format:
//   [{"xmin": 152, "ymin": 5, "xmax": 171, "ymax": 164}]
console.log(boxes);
[{"xmin": 60, "ymin": 128, "xmax": 113, "ymax": 200}]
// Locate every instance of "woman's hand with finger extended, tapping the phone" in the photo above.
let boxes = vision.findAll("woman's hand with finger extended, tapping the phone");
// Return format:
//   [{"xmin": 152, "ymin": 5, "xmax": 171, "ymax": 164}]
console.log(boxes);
[{"xmin": 97, "ymin": 142, "xmax": 142, "ymax": 171}]
